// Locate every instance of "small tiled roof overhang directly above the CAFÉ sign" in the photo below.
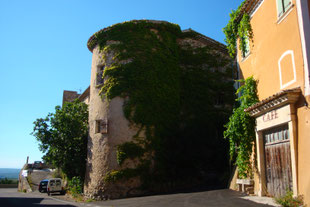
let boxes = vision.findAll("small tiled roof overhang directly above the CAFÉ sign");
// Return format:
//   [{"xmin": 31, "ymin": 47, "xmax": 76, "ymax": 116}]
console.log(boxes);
[{"xmin": 244, "ymin": 87, "xmax": 301, "ymax": 117}]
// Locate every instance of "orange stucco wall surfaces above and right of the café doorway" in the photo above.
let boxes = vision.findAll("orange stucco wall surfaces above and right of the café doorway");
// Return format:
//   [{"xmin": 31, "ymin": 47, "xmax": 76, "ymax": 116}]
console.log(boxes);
[{"xmin": 237, "ymin": 0, "xmax": 310, "ymax": 205}]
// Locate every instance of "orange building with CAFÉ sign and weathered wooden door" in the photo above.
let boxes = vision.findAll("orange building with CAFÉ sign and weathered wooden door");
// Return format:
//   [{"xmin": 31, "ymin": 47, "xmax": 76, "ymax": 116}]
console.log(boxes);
[{"xmin": 231, "ymin": 0, "xmax": 310, "ymax": 205}]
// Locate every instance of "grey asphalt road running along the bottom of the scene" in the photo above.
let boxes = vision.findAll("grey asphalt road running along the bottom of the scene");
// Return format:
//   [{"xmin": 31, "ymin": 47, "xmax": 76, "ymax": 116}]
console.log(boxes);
[{"xmin": 0, "ymin": 188, "xmax": 276, "ymax": 207}]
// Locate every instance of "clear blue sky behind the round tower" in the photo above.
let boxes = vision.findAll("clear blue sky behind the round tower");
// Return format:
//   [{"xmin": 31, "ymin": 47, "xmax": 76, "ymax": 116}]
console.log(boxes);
[{"xmin": 0, "ymin": 0, "xmax": 242, "ymax": 168}]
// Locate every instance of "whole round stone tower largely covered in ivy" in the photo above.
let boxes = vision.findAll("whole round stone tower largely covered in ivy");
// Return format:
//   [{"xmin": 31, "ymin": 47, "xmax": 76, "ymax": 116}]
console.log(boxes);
[{"xmin": 84, "ymin": 20, "xmax": 234, "ymax": 199}]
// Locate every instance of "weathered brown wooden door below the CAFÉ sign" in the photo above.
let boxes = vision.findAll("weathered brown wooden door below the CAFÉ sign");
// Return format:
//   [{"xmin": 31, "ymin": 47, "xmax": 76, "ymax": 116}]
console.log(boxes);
[{"xmin": 264, "ymin": 124, "xmax": 293, "ymax": 197}]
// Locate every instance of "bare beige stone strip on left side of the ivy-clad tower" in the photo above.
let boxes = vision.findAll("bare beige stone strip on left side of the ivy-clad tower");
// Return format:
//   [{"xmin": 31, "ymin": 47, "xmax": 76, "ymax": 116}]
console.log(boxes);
[{"xmin": 84, "ymin": 28, "xmax": 137, "ymax": 199}]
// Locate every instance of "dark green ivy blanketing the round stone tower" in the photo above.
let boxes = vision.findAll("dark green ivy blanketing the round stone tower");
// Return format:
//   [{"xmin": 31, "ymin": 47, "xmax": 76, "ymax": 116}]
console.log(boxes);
[{"xmin": 94, "ymin": 21, "xmax": 233, "ymax": 188}]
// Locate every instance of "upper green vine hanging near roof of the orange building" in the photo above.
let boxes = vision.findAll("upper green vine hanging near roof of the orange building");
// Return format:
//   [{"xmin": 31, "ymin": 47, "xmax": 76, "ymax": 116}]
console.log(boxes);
[{"xmin": 223, "ymin": 0, "xmax": 253, "ymax": 57}]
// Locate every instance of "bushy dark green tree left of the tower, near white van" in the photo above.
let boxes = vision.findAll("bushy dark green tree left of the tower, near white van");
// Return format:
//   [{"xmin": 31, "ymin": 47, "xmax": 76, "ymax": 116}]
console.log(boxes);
[{"xmin": 32, "ymin": 100, "xmax": 88, "ymax": 179}]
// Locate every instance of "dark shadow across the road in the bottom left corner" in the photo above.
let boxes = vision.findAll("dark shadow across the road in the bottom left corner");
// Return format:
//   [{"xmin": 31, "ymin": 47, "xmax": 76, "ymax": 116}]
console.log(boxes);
[{"xmin": 0, "ymin": 197, "xmax": 75, "ymax": 207}]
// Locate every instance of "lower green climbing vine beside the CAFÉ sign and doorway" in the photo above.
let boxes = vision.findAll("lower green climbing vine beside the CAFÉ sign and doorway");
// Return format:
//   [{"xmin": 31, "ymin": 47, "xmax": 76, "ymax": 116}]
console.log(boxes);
[{"xmin": 224, "ymin": 77, "xmax": 258, "ymax": 178}]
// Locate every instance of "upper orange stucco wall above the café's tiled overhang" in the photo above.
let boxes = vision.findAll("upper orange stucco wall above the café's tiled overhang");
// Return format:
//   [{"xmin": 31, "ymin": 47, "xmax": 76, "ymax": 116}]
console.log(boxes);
[{"xmin": 238, "ymin": 0, "xmax": 304, "ymax": 99}]
